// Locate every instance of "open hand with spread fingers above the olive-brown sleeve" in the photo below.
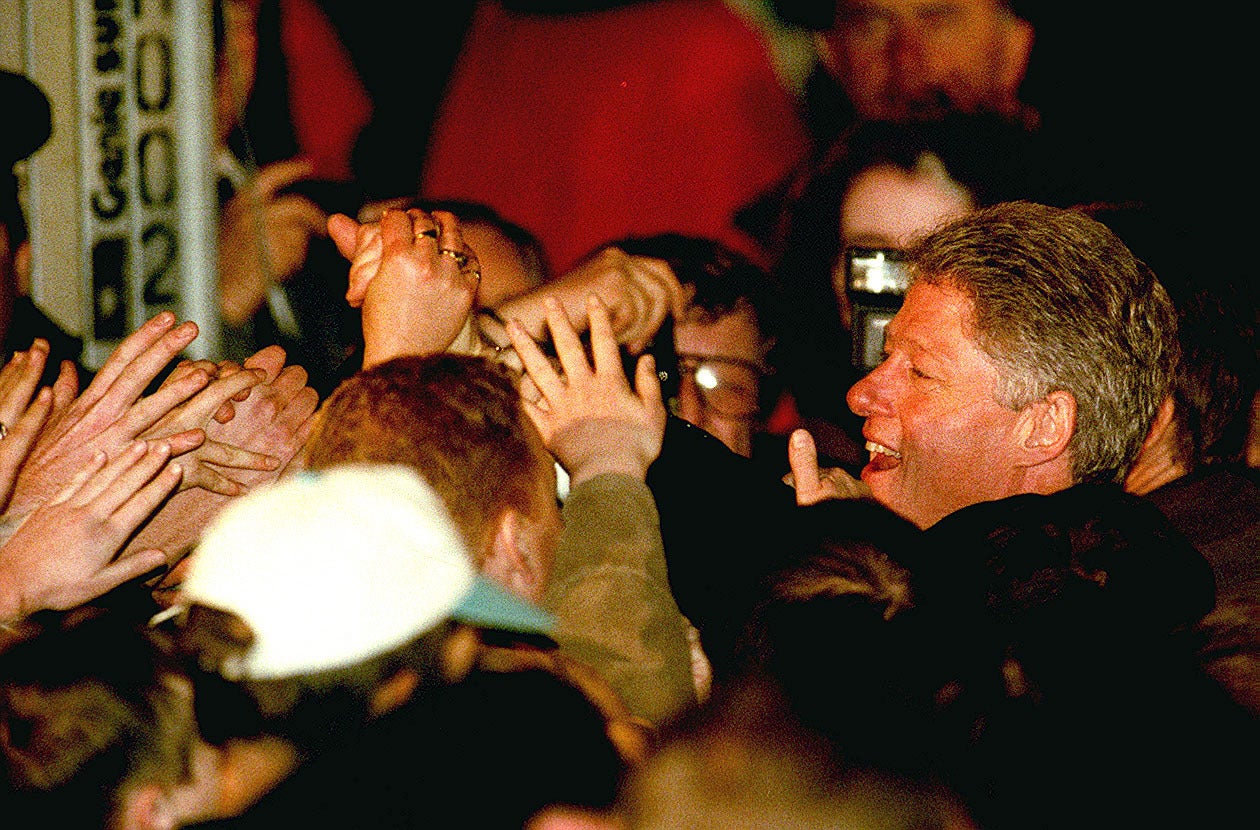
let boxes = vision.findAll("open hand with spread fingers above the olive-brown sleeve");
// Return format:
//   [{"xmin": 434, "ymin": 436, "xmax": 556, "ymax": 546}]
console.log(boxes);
[{"xmin": 508, "ymin": 296, "xmax": 665, "ymax": 485}]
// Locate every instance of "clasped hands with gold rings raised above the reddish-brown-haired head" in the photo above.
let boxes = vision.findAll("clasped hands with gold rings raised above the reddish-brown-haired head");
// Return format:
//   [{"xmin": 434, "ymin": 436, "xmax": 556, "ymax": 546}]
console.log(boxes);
[{"xmin": 328, "ymin": 208, "xmax": 481, "ymax": 368}]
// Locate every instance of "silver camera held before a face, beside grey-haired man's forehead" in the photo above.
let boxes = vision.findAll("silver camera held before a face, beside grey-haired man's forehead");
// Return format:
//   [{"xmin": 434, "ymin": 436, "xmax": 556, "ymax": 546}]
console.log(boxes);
[{"xmin": 844, "ymin": 248, "xmax": 910, "ymax": 372}]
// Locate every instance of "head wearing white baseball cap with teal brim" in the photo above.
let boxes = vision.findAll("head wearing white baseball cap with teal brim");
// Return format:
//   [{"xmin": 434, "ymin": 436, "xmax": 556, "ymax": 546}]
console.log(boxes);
[{"xmin": 180, "ymin": 463, "xmax": 552, "ymax": 741}]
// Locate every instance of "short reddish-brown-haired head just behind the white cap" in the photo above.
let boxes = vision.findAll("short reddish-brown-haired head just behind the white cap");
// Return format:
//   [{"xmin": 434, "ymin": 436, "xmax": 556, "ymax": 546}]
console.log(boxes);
[{"xmin": 306, "ymin": 354, "xmax": 543, "ymax": 559}]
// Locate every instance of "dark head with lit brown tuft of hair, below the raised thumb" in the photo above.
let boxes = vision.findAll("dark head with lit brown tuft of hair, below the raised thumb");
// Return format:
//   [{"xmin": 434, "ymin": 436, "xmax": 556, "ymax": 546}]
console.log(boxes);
[{"xmin": 741, "ymin": 500, "xmax": 930, "ymax": 773}]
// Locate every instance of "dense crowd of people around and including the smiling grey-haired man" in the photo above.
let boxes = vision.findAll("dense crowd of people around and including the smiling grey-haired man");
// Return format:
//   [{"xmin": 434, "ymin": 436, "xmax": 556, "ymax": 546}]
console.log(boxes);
[{"xmin": 0, "ymin": 0, "xmax": 1260, "ymax": 830}]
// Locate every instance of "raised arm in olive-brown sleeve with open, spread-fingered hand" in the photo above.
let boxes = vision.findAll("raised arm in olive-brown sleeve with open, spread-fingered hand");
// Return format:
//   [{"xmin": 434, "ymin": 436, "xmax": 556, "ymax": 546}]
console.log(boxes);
[{"xmin": 508, "ymin": 296, "xmax": 696, "ymax": 723}]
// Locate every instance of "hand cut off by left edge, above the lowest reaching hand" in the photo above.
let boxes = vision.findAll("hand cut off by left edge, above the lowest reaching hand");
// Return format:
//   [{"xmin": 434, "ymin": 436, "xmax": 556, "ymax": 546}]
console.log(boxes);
[{"xmin": 0, "ymin": 340, "xmax": 53, "ymax": 510}]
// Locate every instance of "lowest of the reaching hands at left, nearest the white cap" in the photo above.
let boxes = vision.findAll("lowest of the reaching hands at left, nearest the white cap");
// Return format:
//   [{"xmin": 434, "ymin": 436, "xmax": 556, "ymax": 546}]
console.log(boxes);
[{"xmin": 0, "ymin": 441, "xmax": 181, "ymax": 621}]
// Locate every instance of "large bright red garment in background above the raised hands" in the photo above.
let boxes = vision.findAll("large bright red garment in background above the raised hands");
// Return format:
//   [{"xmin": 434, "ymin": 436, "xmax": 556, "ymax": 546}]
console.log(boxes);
[{"xmin": 421, "ymin": 0, "xmax": 808, "ymax": 273}]
